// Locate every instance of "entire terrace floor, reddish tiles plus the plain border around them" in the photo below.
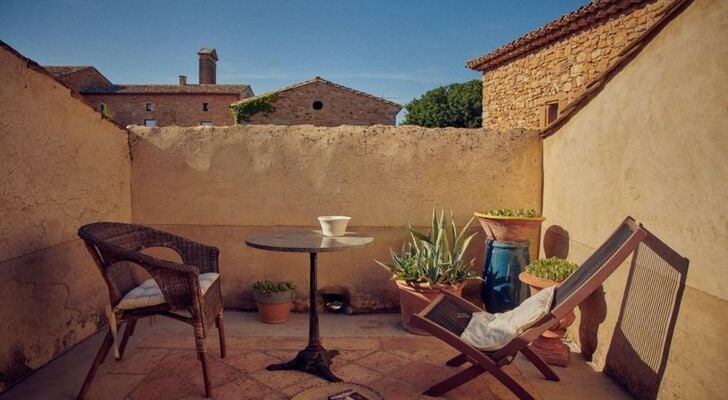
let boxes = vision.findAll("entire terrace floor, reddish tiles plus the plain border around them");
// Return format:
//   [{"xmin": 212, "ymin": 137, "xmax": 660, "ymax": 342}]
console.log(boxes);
[{"xmin": 0, "ymin": 311, "xmax": 629, "ymax": 400}]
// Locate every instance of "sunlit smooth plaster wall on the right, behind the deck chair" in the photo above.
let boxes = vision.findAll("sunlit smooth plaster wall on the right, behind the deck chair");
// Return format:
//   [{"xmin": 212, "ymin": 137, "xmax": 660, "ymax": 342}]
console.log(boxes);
[{"xmin": 543, "ymin": 0, "xmax": 728, "ymax": 399}]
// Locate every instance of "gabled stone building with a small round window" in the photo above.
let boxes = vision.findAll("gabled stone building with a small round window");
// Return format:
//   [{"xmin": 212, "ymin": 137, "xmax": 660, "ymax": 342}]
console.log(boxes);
[{"xmin": 231, "ymin": 76, "xmax": 402, "ymax": 126}]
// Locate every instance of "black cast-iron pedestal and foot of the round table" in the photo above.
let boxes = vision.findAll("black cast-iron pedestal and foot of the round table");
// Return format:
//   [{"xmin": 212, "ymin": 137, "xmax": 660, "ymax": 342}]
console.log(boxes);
[{"xmin": 266, "ymin": 253, "xmax": 341, "ymax": 382}]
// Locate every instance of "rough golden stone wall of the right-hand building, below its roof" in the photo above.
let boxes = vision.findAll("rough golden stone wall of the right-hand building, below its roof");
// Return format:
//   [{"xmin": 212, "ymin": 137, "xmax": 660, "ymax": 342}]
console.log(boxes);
[{"xmin": 483, "ymin": 0, "xmax": 672, "ymax": 130}]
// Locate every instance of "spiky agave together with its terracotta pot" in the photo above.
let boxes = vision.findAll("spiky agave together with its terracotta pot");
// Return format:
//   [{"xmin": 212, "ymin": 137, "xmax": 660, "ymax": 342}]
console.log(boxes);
[{"xmin": 376, "ymin": 210, "xmax": 480, "ymax": 335}]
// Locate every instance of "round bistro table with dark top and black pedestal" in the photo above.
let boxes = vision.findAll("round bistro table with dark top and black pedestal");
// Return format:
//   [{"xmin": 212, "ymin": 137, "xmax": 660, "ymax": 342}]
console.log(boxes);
[{"xmin": 245, "ymin": 229, "xmax": 374, "ymax": 382}]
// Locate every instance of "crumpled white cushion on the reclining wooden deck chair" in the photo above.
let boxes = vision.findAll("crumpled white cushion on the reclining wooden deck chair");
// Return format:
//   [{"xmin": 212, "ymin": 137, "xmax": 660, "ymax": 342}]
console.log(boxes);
[{"xmin": 460, "ymin": 286, "xmax": 556, "ymax": 351}]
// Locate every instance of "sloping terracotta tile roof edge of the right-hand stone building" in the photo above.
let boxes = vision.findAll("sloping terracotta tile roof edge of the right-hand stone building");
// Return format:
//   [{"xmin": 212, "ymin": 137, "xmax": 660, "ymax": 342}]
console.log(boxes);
[{"xmin": 466, "ymin": 0, "xmax": 655, "ymax": 71}]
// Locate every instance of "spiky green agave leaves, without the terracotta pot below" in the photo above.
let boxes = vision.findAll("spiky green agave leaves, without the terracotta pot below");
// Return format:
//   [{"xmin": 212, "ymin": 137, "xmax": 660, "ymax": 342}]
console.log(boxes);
[{"xmin": 376, "ymin": 210, "xmax": 479, "ymax": 286}]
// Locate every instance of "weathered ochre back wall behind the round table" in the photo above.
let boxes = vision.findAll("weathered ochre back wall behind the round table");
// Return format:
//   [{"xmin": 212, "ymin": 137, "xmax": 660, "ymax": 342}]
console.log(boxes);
[{"xmin": 131, "ymin": 125, "xmax": 541, "ymax": 311}]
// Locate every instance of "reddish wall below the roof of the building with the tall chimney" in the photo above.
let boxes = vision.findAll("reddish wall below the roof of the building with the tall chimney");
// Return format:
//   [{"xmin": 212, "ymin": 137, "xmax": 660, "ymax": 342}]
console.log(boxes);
[{"xmin": 83, "ymin": 94, "xmax": 240, "ymax": 126}]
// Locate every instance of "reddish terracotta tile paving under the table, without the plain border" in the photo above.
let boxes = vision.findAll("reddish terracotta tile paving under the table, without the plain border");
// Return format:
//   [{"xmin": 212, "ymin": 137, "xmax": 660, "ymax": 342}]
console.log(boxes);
[{"xmin": 84, "ymin": 336, "xmax": 533, "ymax": 400}]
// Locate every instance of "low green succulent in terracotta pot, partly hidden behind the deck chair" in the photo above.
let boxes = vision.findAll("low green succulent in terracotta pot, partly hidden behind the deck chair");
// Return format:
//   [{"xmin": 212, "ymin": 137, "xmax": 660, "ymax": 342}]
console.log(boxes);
[{"xmin": 518, "ymin": 257, "xmax": 579, "ymax": 367}]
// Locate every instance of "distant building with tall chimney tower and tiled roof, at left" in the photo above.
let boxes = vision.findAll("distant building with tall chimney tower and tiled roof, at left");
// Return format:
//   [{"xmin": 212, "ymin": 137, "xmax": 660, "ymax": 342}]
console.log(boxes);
[{"xmin": 45, "ymin": 48, "xmax": 253, "ymax": 126}]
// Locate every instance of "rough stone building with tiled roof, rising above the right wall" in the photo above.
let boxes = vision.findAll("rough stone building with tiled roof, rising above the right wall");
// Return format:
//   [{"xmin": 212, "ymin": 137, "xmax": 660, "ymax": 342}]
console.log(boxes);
[{"xmin": 467, "ymin": 0, "xmax": 672, "ymax": 129}]
